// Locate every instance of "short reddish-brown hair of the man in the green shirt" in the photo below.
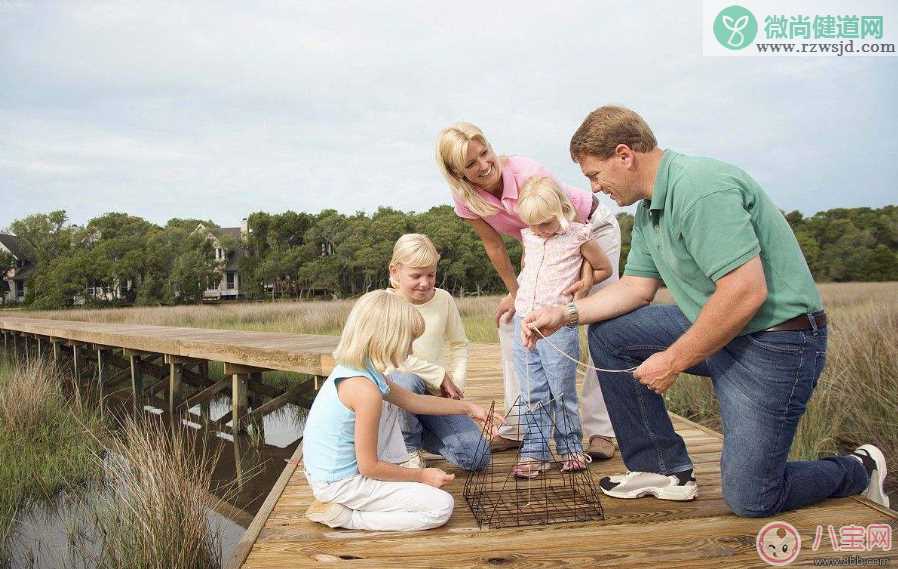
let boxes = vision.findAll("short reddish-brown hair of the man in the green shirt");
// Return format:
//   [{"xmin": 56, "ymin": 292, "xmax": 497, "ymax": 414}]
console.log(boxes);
[{"xmin": 571, "ymin": 105, "xmax": 658, "ymax": 162}]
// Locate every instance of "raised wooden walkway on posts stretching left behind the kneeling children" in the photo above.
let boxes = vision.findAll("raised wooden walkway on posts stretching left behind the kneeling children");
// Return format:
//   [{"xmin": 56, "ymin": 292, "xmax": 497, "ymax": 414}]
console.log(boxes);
[{"xmin": 0, "ymin": 315, "xmax": 337, "ymax": 433}]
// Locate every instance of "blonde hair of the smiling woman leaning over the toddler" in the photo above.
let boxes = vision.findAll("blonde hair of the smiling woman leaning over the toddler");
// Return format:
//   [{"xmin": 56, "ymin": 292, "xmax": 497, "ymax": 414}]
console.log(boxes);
[{"xmin": 436, "ymin": 122, "xmax": 499, "ymax": 217}]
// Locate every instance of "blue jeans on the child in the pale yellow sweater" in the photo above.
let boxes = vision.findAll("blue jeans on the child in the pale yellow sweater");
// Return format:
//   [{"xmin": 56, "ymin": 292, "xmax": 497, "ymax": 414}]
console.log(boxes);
[{"xmin": 390, "ymin": 372, "xmax": 490, "ymax": 470}]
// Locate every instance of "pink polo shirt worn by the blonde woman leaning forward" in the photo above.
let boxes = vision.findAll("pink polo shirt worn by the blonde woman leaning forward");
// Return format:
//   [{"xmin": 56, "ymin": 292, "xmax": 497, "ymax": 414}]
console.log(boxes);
[{"xmin": 452, "ymin": 156, "xmax": 592, "ymax": 241}]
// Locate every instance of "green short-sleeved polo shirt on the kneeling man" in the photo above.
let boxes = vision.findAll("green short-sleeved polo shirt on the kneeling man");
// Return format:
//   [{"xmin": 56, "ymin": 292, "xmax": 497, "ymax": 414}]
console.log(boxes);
[{"xmin": 624, "ymin": 150, "xmax": 823, "ymax": 334}]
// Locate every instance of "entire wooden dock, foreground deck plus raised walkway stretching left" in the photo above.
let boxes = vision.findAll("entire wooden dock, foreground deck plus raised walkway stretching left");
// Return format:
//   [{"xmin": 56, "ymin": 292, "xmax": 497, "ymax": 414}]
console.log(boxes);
[{"xmin": 0, "ymin": 316, "xmax": 898, "ymax": 569}]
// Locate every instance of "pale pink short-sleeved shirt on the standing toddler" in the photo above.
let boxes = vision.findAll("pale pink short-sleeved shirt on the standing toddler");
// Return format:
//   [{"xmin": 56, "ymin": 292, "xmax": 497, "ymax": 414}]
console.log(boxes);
[{"xmin": 514, "ymin": 223, "xmax": 591, "ymax": 316}]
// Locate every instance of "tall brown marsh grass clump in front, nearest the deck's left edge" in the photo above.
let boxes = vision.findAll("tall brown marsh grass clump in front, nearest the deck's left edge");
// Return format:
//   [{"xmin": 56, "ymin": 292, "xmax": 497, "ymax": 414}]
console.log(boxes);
[{"xmin": 73, "ymin": 417, "xmax": 234, "ymax": 569}]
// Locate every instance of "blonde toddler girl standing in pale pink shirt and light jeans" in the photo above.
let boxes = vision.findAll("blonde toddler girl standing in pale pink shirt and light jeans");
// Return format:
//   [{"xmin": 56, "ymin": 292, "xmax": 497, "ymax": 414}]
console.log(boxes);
[{"xmin": 513, "ymin": 176, "xmax": 612, "ymax": 478}]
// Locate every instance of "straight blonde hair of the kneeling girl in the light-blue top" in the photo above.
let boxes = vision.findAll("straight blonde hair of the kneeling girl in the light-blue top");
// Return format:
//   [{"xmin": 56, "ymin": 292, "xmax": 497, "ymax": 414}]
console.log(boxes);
[{"xmin": 334, "ymin": 290, "xmax": 424, "ymax": 372}]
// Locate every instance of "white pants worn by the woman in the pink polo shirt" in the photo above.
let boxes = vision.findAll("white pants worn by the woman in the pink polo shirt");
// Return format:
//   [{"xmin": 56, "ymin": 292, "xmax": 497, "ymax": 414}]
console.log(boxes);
[{"xmin": 499, "ymin": 209, "xmax": 620, "ymax": 441}]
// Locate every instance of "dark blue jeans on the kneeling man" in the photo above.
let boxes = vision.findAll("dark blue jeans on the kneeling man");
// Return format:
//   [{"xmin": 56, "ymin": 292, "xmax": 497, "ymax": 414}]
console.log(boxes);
[{"xmin": 588, "ymin": 305, "xmax": 869, "ymax": 517}]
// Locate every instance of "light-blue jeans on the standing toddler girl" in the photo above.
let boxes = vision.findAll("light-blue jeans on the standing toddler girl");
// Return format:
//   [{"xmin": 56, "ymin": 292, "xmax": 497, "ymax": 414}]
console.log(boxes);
[{"xmin": 514, "ymin": 315, "xmax": 583, "ymax": 460}]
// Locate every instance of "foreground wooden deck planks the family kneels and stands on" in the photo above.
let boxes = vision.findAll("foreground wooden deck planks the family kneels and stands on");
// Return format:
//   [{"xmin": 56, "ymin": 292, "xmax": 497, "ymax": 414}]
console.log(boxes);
[{"xmin": 229, "ymin": 345, "xmax": 898, "ymax": 569}]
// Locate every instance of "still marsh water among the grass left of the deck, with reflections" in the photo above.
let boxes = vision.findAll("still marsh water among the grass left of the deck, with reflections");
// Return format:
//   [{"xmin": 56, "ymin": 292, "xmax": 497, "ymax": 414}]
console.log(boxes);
[{"xmin": 10, "ymin": 397, "xmax": 308, "ymax": 569}]
